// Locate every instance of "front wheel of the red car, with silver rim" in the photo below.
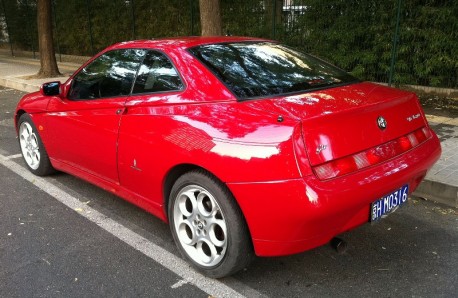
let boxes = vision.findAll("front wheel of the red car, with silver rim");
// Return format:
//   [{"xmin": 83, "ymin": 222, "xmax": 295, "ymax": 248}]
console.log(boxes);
[{"xmin": 17, "ymin": 114, "xmax": 55, "ymax": 176}]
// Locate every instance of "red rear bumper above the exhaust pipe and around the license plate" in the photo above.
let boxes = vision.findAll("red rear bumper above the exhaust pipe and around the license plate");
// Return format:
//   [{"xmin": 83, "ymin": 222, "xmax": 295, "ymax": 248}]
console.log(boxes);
[{"xmin": 228, "ymin": 134, "xmax": 441, "ymax": 256}]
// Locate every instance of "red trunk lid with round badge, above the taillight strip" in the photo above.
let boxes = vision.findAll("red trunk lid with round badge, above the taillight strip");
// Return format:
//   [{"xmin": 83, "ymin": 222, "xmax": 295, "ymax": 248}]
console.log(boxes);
[{"xmin": 245, "ymin": 82, "xmax": 426, "ymax": 166}]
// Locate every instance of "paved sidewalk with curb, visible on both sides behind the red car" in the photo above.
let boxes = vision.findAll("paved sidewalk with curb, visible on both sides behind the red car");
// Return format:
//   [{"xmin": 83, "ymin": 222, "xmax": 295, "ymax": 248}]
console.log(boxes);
[{"xmin": 0, "ymin": 51, "xmax": 458, "ymax": 208}]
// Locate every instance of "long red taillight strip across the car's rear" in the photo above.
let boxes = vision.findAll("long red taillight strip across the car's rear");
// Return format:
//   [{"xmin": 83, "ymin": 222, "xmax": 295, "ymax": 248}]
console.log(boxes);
[{"xmin": 313, "ymin": 127, "xmax": 431, "ymax": 180}]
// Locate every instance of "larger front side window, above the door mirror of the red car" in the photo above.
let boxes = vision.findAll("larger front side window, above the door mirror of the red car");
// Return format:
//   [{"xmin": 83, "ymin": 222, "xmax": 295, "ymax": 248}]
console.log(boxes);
[{"xmin": 68, "ymin": 49, "xmax": 146, "ymax": 100}]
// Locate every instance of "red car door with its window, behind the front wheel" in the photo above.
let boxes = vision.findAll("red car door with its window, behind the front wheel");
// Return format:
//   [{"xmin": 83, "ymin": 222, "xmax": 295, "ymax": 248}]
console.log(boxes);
[{"xmin": 46, "ymin": 49, "xmax": 145, "ymax": 183}]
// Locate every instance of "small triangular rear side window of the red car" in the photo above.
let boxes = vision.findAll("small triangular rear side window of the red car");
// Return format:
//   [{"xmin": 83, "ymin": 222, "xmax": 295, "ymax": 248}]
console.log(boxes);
[{"xmin": 132, "ymin": 51, "xmax": 183, "ymax": 94}]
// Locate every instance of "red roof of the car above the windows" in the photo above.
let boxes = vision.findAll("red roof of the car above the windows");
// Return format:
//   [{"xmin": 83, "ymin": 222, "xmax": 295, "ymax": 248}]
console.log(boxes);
[{"xmin": 106, "ymin": 36, "xmax": 269, "ymax": 50}]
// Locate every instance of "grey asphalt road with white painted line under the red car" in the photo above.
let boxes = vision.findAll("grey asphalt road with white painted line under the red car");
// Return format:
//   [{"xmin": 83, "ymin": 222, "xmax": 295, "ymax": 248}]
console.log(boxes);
[{"xmin": 0, "ymin": 87, "xmax": 458, "ymax": 297}]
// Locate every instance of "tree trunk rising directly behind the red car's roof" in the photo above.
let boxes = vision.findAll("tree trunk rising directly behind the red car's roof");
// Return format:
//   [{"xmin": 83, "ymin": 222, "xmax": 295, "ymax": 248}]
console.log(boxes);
[{"xmin": 199, "ymin": 0, "xmax": 222, "ymax": 36}]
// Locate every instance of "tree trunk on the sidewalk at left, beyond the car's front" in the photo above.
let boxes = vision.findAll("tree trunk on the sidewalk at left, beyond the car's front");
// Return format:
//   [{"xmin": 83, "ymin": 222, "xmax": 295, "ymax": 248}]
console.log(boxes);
[{"xmin": 37, "ymin": 0, "xmax": 62, "ymax": 78}]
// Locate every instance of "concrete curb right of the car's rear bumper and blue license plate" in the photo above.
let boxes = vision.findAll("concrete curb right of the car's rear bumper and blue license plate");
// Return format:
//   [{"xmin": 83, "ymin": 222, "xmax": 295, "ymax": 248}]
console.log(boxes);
[{"xmin": 413, "ymin": 180, "xmax": 458, "ymax": 208}]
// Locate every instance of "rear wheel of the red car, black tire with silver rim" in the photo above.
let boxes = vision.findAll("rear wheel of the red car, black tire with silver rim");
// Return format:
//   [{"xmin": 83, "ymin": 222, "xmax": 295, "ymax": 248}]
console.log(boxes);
[{"xmin": 168, "ymin": 170, "xmax": 254, "ymax": 278}]
